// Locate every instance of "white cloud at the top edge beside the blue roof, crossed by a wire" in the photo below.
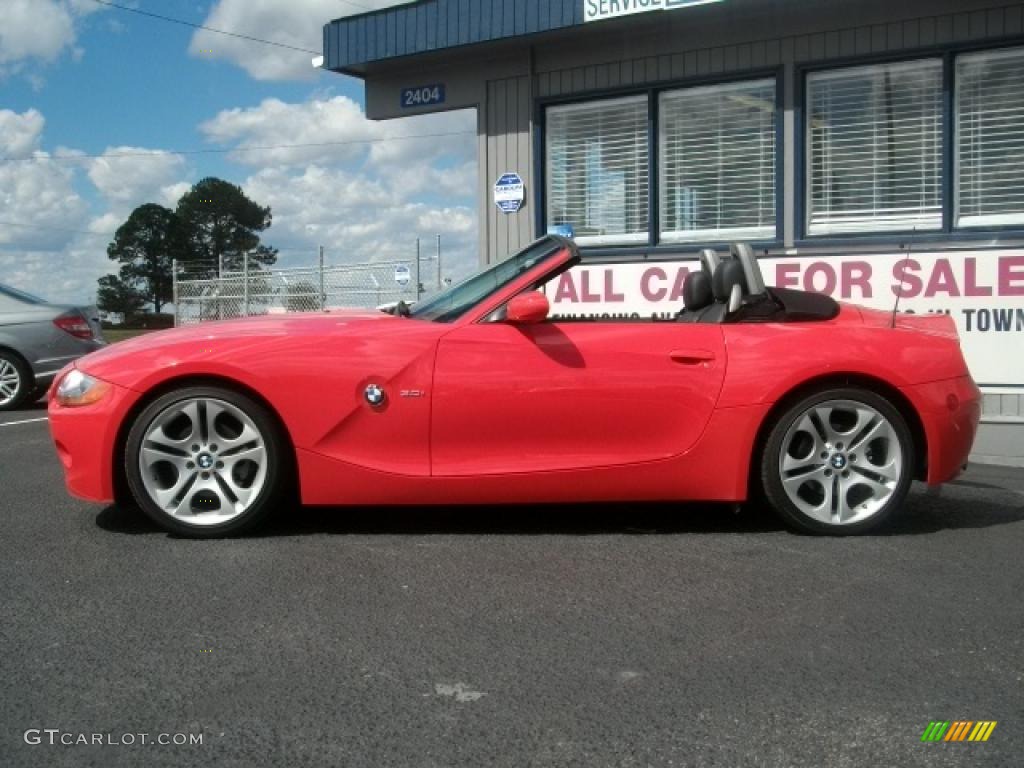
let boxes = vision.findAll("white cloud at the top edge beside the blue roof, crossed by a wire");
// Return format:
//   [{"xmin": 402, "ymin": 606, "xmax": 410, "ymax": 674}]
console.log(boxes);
[{"xmin": 188, "ymin": 0, "xmax": 398, "ymax": 80}]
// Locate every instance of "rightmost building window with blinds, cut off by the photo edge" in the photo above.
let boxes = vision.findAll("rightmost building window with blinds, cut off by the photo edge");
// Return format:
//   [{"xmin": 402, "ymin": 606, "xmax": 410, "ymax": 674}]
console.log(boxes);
[{"xmin": 955, "ymin": 48, "xmax": 1024, "ymax": 226}]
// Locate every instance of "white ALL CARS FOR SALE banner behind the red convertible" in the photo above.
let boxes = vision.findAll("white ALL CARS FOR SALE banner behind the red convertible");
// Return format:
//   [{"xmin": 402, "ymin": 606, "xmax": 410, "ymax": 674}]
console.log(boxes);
[{"xmin": 545, "ymin": 250, "xmax": 1024, "ymax": 391}]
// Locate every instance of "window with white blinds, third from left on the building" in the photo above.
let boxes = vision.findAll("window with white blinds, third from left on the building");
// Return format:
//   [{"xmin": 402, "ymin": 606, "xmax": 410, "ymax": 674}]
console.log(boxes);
[{"xmin": 806, "ymin": 59, "xmax": 943, "ymax": 234}]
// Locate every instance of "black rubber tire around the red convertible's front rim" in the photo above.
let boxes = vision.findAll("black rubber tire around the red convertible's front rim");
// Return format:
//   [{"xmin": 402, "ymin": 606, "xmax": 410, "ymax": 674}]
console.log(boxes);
[{"xmin": 124, "ymin": 386, "xmax": 291, "ymax": 539}]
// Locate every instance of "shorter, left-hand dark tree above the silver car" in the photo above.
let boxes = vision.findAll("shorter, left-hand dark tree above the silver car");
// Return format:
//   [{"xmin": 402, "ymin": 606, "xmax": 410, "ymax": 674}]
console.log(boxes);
[{"xmin": 99, "ymin": 203, "xmax": 181, "ymax": 313}]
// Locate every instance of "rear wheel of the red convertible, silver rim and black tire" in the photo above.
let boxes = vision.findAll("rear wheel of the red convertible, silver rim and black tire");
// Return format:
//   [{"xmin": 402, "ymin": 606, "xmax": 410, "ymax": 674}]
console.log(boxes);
[{"xmin": 761, "ymin": 388, "xmax": 914, "ymax": 536}]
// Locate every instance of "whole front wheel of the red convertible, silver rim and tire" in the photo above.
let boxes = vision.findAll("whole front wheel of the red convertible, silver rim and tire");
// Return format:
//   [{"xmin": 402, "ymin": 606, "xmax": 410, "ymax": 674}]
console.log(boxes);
[{"xmin": 125, "ymin": 386, "xmax": 288, "ymax": 539}]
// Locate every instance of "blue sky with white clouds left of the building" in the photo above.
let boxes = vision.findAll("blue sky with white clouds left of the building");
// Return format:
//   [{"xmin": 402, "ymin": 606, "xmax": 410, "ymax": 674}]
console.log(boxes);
[{"xmin": 0, "ymin": 0, "xmax": 477, "ymax": 303}]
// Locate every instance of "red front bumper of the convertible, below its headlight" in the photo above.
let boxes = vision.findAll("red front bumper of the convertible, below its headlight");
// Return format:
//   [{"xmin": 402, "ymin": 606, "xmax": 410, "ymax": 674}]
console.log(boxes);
[{"xmin": 48, "ymin": 384, "xmax": 139, "ymax": 503}]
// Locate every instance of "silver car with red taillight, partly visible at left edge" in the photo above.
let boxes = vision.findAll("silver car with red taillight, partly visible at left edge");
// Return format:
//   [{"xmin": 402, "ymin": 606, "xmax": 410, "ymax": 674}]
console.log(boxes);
[{"xmin": 0, "ymin": 284, "xmax": 105, "ymax": 411}]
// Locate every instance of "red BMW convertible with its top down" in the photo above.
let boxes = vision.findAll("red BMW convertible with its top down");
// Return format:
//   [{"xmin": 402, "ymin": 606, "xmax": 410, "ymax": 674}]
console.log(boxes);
[{"xmin": 49, "ymin": 236, "xmax": 980, "ymax": 537}]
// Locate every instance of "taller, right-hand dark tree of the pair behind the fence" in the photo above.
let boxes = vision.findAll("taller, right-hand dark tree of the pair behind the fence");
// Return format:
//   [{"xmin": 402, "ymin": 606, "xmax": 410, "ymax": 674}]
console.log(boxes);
[{"xmin": 176, "ymin": 177, "xmax": 278, "ymax": 275}]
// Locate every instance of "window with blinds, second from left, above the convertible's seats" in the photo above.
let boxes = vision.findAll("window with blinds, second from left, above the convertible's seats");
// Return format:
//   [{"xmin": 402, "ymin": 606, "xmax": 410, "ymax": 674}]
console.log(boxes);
[{"xmin": 658, "ymin": 80, "xmax": 775, "ymax": 243}]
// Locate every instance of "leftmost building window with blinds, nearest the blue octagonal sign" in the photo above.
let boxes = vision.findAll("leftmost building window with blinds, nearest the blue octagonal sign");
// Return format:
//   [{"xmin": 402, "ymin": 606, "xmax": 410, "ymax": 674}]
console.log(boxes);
[{"xmin": 545, "ymin": 94, "xmax": 650, "ymax": 245}]
